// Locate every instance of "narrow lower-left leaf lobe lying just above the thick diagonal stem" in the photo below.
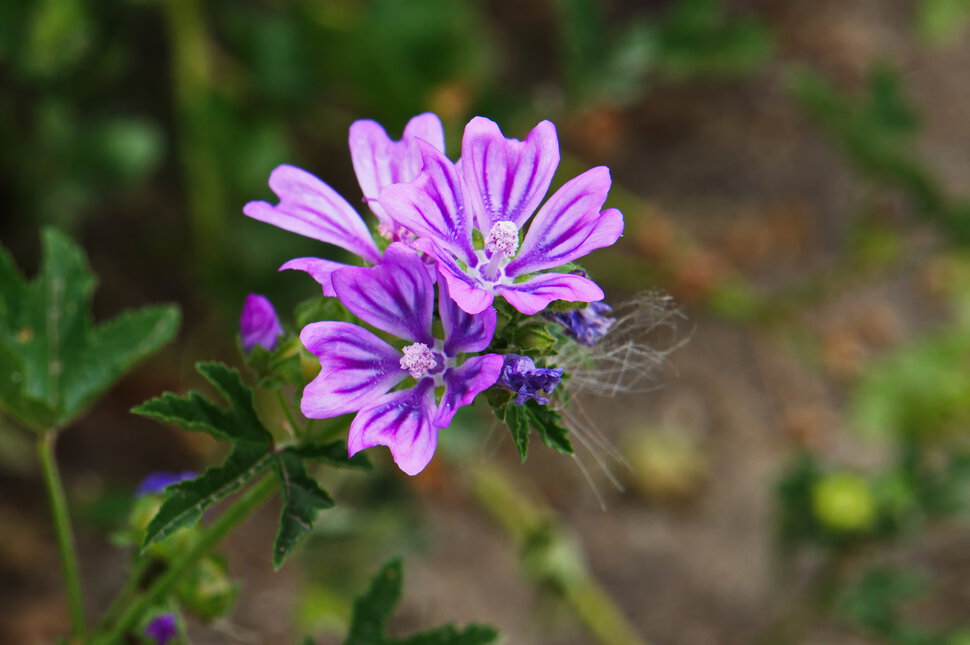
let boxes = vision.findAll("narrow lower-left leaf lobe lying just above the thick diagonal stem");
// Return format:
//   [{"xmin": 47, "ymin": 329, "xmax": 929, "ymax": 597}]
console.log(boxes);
[{"xmin": 142, "ymin": 443, "xmax": 273, "ymax": 548}]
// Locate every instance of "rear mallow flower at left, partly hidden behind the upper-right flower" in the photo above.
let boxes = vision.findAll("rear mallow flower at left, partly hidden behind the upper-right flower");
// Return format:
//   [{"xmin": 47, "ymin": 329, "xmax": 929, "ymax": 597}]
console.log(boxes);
[{"xmin": 243, "ymin": 113, "xmax": 445, "ymax": 296}]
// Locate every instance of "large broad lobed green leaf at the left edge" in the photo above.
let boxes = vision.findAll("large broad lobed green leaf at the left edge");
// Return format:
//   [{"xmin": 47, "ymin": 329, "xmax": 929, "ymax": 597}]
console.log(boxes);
[{"xmin": 0, "ymin": 229, "xmax": 179, "ymax": 430}]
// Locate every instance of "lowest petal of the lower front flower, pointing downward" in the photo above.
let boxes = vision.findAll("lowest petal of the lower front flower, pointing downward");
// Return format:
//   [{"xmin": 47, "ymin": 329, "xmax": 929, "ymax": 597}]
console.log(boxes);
[{"xmin": 347, "ymin": 378, "xmax": 438, "ymax": 475}]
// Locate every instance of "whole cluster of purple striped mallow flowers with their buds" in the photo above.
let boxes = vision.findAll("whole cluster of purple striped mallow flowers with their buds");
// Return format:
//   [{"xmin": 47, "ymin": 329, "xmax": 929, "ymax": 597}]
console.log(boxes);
[{"xmin": 241, "ymin": 114, "xmax": 623, "ymax": 475}]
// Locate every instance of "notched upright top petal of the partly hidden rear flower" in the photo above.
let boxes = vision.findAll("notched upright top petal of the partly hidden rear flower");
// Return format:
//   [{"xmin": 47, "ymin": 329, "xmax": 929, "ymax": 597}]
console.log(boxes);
[{"xmin": 349, "ymin": 112, "xmax": 445, "ymax": 223}]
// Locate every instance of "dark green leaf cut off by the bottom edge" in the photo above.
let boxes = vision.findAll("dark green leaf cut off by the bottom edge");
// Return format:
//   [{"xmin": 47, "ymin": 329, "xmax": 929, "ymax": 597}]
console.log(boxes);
[{"xmin": 344, "ymin": 559, "xmax": 498, "ymax": 645}]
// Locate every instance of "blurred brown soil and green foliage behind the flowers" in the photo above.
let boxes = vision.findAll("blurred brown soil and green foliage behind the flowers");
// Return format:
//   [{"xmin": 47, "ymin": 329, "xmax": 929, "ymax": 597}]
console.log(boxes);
[{"xmin": 0, "ymin": 0, "xmax": 970, "ymax": 645}]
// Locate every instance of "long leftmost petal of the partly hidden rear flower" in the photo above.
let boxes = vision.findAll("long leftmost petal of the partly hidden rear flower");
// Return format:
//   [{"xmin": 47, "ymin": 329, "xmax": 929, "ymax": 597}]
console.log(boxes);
[{"xmin": 243, "ymin": 165, "xmax": 381, "ymax": 263}]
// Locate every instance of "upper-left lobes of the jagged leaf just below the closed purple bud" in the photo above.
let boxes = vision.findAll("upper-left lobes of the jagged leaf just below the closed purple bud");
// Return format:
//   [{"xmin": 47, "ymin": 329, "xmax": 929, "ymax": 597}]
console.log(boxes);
[{"xmin": 132, "ymin": 362, "xmax": 273, "ymax": 449}]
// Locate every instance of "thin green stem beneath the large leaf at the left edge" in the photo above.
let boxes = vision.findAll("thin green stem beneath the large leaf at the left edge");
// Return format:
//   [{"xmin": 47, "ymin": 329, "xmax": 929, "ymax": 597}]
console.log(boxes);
[{"xmin": 37, "ymin": 431, "xmax": 86, "ymax": 641}]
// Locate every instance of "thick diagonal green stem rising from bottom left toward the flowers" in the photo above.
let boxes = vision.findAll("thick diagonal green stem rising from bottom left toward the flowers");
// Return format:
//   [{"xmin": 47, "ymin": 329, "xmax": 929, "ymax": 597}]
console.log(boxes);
[{"xmin": 94, "ymin": 476, "xmax": 276, "ymax": 645}]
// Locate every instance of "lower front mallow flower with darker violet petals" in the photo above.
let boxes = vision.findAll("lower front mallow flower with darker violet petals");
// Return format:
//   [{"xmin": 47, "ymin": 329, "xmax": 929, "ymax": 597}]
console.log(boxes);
[{"xmin": 300, "ymin": 243, "xmax": 502, "ymax": 475}]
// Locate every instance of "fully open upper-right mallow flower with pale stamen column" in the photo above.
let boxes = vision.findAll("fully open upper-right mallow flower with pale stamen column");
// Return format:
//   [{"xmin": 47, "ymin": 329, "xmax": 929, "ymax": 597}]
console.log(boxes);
[{"xmin": 380, "ymin": 117, "xmax": 623, "ymax": 314}]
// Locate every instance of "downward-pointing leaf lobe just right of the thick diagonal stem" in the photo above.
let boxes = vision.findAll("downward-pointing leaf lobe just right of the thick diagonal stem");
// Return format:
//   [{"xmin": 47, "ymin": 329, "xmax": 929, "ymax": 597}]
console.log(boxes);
[{"xmin": 273, "ymin": 452, "xmax": 333, "ymax": 570}]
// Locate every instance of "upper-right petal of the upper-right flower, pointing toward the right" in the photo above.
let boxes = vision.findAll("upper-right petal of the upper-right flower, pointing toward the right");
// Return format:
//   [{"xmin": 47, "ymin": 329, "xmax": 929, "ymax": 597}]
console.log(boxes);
[{"xmin": 505, "ymin": 166, "xmax": 623, "ymax": 277}]
